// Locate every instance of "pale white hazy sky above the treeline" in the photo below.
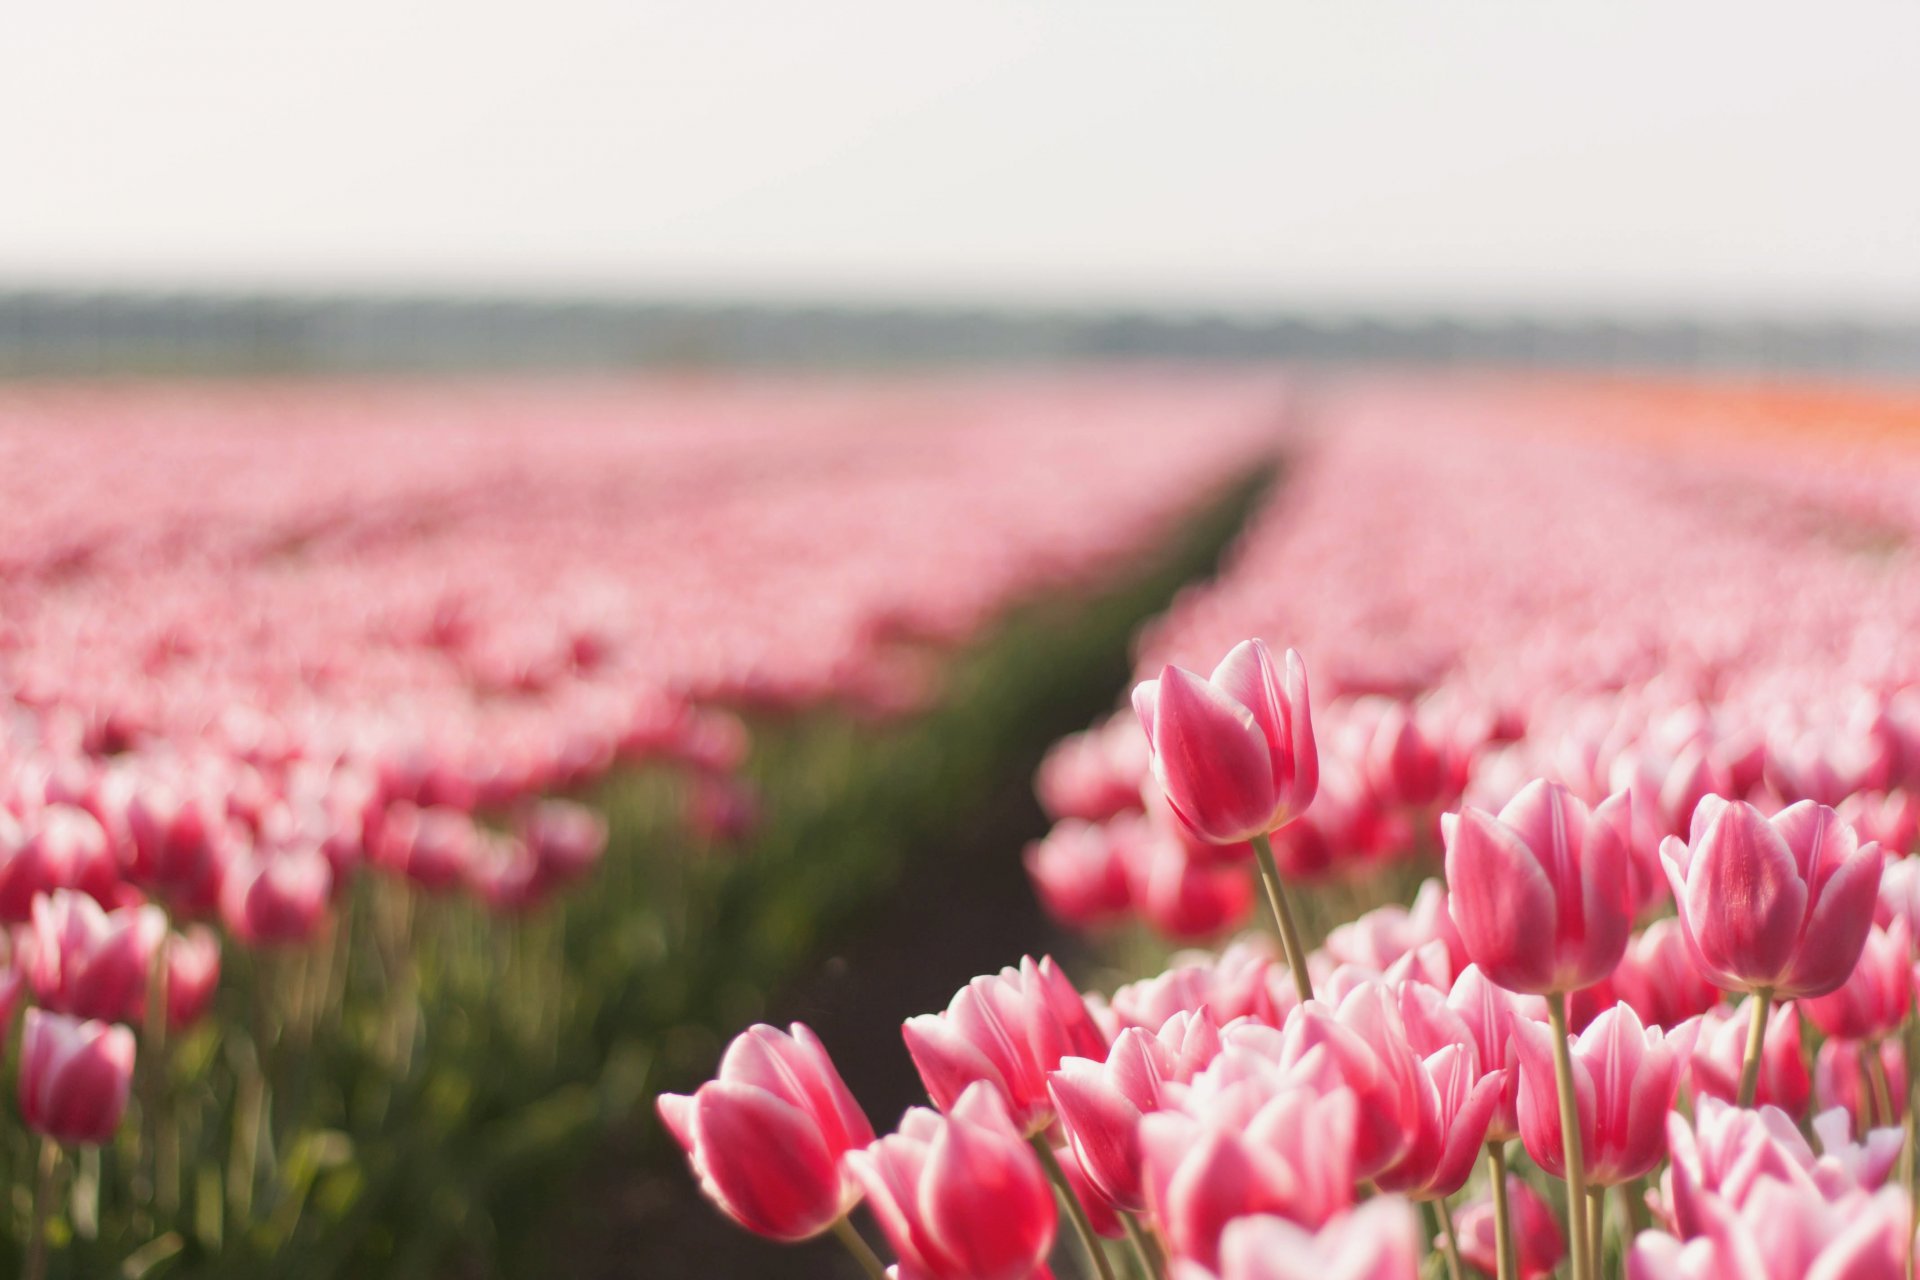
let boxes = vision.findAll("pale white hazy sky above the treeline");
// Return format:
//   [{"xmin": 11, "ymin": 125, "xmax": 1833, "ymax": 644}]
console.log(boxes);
[{"xmin": 0, "ymin": 0, "xmax": 1920, "ymax": 317}]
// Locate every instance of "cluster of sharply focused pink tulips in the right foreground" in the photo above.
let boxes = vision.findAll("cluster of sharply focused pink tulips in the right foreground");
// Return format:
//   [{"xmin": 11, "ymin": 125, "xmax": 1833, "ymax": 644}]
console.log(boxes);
[{"xmin": 659, "ymin": 641, "xmax": 1920, "ymax": 1280}]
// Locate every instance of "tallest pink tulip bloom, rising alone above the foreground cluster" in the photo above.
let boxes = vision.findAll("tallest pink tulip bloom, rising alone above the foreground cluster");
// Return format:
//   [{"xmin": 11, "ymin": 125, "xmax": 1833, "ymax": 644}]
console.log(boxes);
[{"xmin": 1133, "ymin": 639, "xmax": 1319, "ymax": 844}]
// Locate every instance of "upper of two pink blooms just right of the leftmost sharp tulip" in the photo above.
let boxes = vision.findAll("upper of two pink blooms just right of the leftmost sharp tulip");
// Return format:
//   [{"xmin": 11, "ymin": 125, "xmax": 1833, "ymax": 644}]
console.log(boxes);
[{"xmin": 900, "ymin": 956, "xmax": 1106, "ymax": 1134}]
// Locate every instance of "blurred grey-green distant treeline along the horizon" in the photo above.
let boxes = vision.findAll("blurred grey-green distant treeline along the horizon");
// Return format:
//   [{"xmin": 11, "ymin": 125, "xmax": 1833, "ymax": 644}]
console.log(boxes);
[{"xmin": 0, "ymin": 292, "xmax": 1920, "ymax": 376}]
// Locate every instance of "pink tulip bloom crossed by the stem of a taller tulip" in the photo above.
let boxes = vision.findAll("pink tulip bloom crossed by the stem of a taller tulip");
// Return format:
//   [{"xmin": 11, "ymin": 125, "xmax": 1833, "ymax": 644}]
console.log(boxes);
[{"xmin": 1515, "ymin": 1004, "xmax": 1697, "ymax": 1186}]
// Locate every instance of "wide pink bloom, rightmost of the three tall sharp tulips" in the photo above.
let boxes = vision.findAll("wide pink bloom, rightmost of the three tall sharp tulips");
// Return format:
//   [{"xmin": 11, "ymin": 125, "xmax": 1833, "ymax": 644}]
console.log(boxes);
[{"xmin": 1661, "ymin": 796, "xmax": 1880, "ymax": 1000}]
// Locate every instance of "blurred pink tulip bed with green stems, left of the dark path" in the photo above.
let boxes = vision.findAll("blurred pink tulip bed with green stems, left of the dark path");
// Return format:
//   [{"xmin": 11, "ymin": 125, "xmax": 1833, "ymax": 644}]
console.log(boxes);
[{"xmin": 0, "ymin": 374, "xmax": 1283, "ymax": 1276}]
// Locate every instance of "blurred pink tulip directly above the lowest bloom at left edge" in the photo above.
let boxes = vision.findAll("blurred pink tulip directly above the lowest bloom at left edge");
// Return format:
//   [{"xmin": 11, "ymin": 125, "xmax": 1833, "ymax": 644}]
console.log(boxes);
[{"xmin": 27, "ymin": 889, "xmax": 167, "ymax": 1021}]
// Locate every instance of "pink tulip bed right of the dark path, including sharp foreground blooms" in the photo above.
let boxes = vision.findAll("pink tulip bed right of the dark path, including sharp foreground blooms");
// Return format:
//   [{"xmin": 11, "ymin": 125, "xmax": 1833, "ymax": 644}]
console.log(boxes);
[{"xmin": 675, "ymin": 380, "xmax": 1920, "ymax": 1280}]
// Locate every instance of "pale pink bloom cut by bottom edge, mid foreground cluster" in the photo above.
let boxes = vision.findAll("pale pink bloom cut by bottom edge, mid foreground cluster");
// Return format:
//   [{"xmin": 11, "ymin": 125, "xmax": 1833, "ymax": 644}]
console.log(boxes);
[{"xmin": 1177, "ymin": 1196, "xmax": 1421, "ymax": 1280}]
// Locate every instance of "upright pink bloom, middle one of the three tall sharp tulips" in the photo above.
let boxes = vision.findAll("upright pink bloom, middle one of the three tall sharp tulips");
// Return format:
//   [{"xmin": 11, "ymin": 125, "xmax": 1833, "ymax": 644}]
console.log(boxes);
[{"xmin": 1440, "ymin": 779, "xmax": 1632, "ymax": 996}]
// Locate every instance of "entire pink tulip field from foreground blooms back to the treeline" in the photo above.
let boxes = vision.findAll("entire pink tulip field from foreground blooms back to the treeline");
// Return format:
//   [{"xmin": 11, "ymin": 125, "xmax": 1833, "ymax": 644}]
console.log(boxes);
[{"xmin": 11, "ymin": 368, "xmax": 1920, "ymax": 1280}]
